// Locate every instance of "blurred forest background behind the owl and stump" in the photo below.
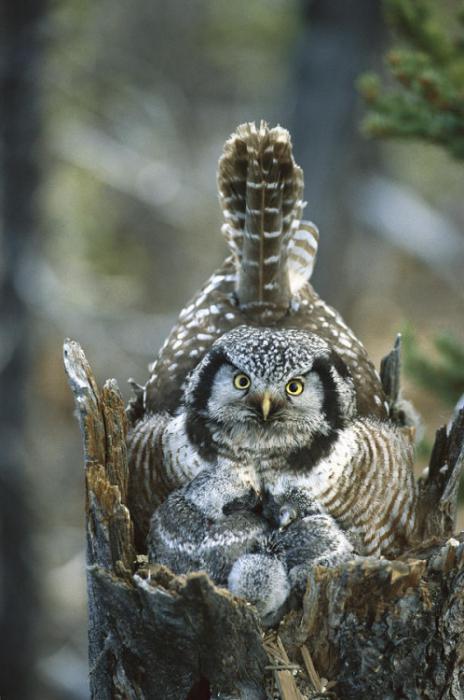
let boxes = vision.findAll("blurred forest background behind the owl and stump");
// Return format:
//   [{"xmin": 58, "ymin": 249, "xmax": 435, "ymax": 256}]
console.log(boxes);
[{"xmin": 0, "ymin": 0, "xmax": 464, "ymax": 700}]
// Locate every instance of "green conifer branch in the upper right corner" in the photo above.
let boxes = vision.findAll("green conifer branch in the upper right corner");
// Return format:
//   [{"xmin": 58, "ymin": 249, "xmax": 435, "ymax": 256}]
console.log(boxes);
[{"xmin": 358, "ymin": 0, "xmax": 464, "ymax": 159}]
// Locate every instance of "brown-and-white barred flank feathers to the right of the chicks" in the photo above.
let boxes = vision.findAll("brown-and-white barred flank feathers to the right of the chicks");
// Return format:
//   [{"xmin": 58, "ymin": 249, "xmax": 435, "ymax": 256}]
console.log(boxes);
[{"xmin": 263, "ymin": 418, "xmax": 417, "ymax": 556}]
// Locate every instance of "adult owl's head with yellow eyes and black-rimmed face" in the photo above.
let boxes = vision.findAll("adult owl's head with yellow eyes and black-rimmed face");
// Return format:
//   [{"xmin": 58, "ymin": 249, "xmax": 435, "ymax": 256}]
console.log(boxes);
[{"xmin": 185, "ymin": 326, "xmax": 356, "ymax": 454}]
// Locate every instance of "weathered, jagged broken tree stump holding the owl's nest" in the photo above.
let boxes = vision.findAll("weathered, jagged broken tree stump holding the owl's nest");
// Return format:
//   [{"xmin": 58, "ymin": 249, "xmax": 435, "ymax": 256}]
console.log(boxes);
[{"xmin": 64, "ymin": 341, "xmax": 464, "ymax": 700}]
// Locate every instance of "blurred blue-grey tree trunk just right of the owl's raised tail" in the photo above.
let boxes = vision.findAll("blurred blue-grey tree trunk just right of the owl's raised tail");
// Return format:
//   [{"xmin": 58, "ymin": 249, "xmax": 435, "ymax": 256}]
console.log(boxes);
[{"xmin": 288, "ymin": 0, "xmax": 383, "ymax": 312}]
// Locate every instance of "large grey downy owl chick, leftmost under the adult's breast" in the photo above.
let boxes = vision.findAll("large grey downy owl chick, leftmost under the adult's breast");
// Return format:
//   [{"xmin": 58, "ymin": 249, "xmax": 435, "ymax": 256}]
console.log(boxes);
[{"xmin": 148, "ymin": 459, "xmax": 271, "ymax": 585}]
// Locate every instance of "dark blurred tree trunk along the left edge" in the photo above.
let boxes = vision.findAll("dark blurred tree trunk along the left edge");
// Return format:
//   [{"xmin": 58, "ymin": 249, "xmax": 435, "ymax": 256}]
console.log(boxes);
[{"xmin": 0, "ymin": 0, "xmax": 44, "ymax": 699}]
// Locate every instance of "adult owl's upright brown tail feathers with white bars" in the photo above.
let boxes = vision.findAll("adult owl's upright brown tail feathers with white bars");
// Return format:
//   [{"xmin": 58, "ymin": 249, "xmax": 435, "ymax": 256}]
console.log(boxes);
[{"xmin": 218, "ymin": 122, "xmax": 319, "ymax": 309}]
